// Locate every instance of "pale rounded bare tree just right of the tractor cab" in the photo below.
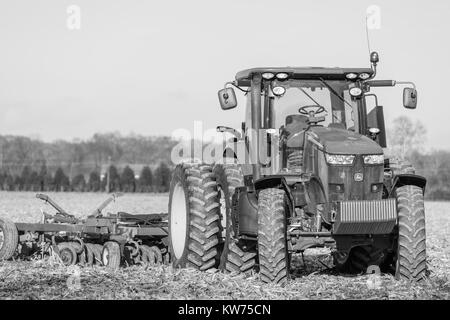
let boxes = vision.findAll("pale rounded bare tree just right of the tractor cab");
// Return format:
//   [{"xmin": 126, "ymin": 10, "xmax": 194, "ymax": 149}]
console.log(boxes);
[{"xmin": 390, "ymin": 116, "xmax": 426, "ymax": 158}]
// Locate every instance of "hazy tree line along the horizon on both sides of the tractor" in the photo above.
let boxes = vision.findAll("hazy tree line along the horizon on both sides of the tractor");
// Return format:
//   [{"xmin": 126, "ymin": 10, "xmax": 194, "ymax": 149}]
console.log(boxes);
[{"xmin": 0, "ymin": 116, "xmax": 450, "ymax": 200}]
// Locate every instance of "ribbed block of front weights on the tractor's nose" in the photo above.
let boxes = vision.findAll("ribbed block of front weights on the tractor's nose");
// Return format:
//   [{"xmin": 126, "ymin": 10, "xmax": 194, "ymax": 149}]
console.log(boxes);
[{"xmin": 333, "ymin": 199, "xmax": 397, "ymax": 235}]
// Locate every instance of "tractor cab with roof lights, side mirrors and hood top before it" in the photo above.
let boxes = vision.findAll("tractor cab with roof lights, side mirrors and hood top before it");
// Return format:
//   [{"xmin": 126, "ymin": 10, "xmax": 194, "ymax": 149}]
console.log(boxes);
[{"xmin": 219, "ymin": 53, "xmax": 417, "ymax": 184}]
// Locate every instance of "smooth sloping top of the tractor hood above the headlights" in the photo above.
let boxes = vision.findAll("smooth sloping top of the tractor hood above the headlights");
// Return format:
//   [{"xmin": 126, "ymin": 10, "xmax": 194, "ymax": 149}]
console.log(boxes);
[{"xmin": 307, "ymin": 127, "xmax": 383, "ymax": 154}]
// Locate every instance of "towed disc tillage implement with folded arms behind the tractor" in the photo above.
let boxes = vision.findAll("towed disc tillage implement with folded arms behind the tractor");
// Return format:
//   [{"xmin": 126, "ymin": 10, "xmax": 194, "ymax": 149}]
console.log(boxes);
[{"xmin": 0, "ymin": 194, "xmax": 169, "ymax": 269}]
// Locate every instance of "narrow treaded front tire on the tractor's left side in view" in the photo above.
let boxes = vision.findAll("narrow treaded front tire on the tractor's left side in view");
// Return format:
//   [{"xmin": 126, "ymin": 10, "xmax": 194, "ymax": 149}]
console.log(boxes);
[{"xmin": 258, "ymin": 189, "xmax": 290, "ymax": 283}]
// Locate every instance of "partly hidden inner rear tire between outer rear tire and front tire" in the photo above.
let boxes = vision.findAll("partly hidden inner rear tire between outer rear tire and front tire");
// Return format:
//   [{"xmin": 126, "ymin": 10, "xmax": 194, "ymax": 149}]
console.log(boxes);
[{"xmin": 214, "ymin": 159, "xmax": 256, "ymax": 273}]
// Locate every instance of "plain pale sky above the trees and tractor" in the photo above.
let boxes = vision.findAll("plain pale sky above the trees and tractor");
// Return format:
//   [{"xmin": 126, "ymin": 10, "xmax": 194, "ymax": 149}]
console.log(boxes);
[{"xmin": 0, "ymin": 0, "xmax": 450, "ymax": 149}]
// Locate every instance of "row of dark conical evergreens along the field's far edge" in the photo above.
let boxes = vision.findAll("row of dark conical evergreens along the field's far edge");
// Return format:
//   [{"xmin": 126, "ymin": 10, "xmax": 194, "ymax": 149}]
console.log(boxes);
[{"xmin": 0, "ymin": 162, "xmax": 171, "ymax": 192}]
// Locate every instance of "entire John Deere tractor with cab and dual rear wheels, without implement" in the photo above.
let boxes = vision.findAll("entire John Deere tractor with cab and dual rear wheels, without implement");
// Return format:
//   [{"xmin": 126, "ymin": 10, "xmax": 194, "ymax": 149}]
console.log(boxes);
[{"xmin": 169, "ymin": 52, "xmax": 427, "ymax": 283}]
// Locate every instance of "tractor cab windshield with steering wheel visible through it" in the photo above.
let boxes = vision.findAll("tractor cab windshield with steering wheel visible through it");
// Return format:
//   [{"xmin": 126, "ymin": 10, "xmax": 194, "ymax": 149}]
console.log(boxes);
[{"xmin": 272, "ymin": 80, "xmax": 358, "ymax": 131}]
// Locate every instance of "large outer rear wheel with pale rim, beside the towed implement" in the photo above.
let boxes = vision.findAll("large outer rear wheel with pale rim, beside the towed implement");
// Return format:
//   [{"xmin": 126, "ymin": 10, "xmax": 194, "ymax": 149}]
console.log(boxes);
[{"xmin": 169, "ymin": 163, "xmax": 220, "ymax": 270}]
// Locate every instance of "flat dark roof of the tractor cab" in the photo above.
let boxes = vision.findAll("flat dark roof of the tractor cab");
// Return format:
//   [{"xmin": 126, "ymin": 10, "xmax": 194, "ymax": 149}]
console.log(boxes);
[{"xmin": 236, "ymin": 67, "xmax": 373, "ymax": 87}]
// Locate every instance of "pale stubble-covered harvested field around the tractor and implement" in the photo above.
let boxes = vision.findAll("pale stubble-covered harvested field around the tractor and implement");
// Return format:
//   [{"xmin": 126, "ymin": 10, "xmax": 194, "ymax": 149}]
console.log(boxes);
[{"xmin": 0, "ymin": 192, "xmax": 450, "ymax": 300}]
